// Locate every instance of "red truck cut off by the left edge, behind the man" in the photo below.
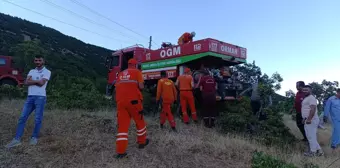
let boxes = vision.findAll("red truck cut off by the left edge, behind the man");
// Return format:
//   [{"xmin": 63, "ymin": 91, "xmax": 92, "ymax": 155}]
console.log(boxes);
[{"xmin": 0, "ymin": 55, "xmax": 24, "ymax": 87}]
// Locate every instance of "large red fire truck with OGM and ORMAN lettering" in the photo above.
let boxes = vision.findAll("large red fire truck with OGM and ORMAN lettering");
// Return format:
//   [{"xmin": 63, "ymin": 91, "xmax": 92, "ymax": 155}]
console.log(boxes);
[{"xmin": 106, "ymin": 38, "xmax": 247, "ymax": 100}]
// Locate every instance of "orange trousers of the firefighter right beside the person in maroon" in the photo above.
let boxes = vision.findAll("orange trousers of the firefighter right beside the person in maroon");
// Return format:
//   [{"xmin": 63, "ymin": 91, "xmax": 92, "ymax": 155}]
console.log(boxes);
[{"xmin": 179, "ymin": 91, "xmax": 197, "ymax": 123}]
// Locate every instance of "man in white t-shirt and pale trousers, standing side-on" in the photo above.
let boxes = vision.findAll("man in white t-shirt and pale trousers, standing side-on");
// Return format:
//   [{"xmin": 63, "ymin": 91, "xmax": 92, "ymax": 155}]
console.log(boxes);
[{"xmin": 301, "ymin": 85, "xmax": 323, "ymax": 156}]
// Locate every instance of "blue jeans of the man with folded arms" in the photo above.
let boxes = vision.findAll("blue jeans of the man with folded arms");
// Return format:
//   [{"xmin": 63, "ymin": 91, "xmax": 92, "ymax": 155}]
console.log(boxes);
[{"xmin": 15, "ymin": 96, "xmax": 46, "ymax": 140}]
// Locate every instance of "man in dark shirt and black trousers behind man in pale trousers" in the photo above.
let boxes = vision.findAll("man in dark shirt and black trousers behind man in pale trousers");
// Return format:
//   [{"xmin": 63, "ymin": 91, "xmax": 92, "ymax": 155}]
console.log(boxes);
[{"xmin": 291, "ymin": 81, "xmax": 307, "ymax": 141}]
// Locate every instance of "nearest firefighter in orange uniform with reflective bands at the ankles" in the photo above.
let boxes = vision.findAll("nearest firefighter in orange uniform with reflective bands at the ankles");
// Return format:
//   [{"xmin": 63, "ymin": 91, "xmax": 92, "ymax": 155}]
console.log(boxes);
[{"xmin": 115, "ymin": 59, "xmax": 149, "ymax": 159}]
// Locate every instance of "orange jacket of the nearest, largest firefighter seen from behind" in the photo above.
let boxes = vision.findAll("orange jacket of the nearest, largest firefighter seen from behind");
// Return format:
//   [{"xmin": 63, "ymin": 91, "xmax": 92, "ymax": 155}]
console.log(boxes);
[{"xmin": 115, "ymin": 68, "xmax": 144, "ymax": 101}]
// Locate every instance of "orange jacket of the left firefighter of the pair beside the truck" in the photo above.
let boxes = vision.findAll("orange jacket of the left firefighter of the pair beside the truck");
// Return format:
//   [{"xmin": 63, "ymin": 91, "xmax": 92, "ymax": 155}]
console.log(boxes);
[{"xmin": 156, "ymin": 78, "xmax": 177, "ymax": 103}]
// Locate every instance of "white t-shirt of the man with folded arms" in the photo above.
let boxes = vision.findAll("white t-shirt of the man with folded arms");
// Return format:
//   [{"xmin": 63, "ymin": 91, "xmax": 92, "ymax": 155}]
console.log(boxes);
[{"xmin": 27, "ymin": 67, "xmax": 51, "ymax": 96}]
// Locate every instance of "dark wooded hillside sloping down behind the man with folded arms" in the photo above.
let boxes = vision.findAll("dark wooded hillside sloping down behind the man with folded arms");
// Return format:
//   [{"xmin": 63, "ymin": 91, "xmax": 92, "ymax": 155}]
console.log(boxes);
[{"xmin": 0, "ymin": 13, "xmax": 112, "ymax": 91}]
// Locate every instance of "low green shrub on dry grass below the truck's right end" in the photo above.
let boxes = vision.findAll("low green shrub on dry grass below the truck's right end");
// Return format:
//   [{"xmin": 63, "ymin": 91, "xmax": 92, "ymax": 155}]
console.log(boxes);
[{"xmin": 218, "ymin": 98, "xmax": 296, "ymax": 146}]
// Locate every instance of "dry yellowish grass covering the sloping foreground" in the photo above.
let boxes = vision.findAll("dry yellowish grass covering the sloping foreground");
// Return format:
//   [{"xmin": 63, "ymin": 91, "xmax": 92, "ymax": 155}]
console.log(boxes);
[{"xmin": 0, "ymin": 101, "xmax": 340, "ymax": 168}]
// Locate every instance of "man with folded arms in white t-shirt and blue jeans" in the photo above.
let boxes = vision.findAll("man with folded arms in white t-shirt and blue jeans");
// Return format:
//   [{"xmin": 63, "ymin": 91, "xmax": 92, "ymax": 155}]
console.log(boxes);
[{"xmin": 6, "ymin": 56, "xmax": 51, "ymax": 148}]
